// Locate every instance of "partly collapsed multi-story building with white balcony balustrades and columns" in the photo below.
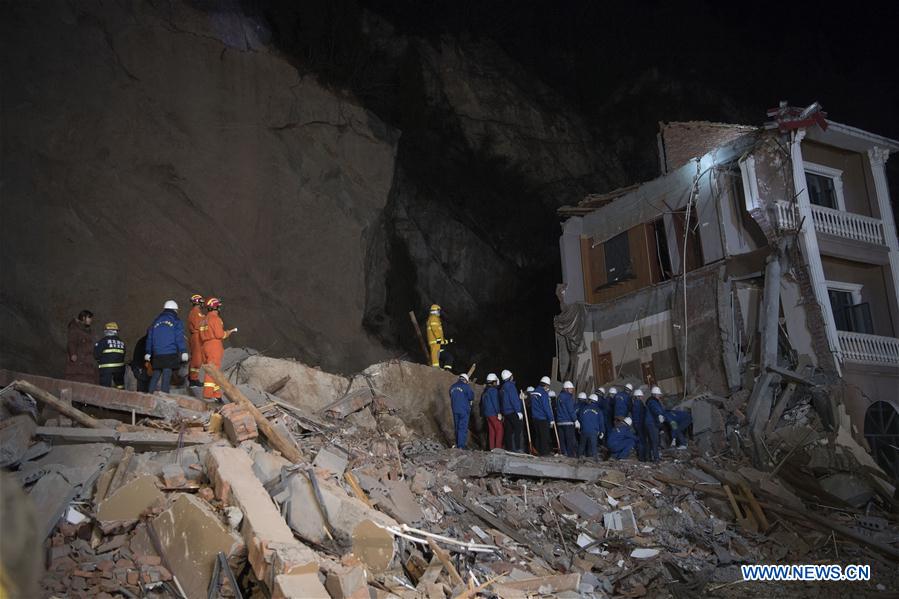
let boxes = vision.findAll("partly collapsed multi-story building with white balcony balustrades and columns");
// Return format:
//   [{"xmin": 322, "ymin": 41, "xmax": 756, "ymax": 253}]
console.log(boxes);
[{"xmin": 555, "ymin": 103, "xmax": 899, "ymax": 471}]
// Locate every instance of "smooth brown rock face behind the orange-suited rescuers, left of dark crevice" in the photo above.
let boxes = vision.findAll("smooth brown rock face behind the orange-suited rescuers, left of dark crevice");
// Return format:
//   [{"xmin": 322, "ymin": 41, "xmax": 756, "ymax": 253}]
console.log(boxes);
[{"xmin": 0, "ymin": 2, "xmax": 399, "ymax": 374}]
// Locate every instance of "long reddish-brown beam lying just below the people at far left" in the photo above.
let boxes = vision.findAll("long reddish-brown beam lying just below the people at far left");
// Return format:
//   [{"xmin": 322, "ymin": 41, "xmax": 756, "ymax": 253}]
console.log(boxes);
[{"xmin": 0, "ymin": 369, "xmax": 209, "ymax": 426}]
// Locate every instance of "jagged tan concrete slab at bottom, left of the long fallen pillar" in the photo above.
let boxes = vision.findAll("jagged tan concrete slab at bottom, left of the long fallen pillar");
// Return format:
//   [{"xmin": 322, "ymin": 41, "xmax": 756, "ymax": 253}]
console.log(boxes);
[{"xmin": 150, "ymin": 493, "xmax": 246, "ymax": 599}]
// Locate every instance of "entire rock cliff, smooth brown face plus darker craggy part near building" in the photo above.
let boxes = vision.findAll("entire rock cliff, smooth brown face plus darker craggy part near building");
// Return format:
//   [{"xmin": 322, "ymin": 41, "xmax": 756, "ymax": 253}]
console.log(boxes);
[{"xmin": 0, "ymin": 1, "xmax": 625, "ymax": 374}]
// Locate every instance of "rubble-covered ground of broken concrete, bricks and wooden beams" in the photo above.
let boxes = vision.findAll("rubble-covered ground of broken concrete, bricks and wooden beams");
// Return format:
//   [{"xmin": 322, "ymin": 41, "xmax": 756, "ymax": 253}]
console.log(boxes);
[{"xmin": 0, "ymin": 350, "xmax": 899, "ymax": 598}]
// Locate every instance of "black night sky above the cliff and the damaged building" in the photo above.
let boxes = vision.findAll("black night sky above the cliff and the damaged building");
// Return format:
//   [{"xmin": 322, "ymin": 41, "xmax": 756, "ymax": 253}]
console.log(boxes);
[{"xmin": 367, "ymin": 0, "xmax": 899, "ymax": 138}]
